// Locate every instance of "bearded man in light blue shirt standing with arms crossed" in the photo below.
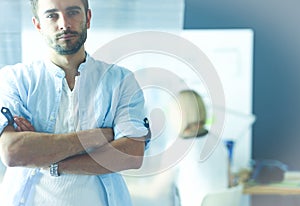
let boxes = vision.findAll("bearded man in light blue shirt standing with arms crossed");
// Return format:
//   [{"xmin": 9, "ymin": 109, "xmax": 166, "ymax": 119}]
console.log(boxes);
[{"xmin": 0, "ymin": 0, "xmax": 148, "ymax": 206}]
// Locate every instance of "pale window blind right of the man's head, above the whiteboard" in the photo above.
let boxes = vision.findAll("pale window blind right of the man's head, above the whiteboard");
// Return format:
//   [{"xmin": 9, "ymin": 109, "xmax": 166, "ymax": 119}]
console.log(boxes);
[{"xmin": 90, "ymin": 0, "xmax": 184, "ymax": 30}]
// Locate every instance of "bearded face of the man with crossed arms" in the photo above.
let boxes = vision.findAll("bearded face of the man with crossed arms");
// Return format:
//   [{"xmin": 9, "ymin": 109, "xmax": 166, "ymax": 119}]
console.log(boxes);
[{"xmin": 33, "ymin": 0, "xmax": 91, "ymax": 55}]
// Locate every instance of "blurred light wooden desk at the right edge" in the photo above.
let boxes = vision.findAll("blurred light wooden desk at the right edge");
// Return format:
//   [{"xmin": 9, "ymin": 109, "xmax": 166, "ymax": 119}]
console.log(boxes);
[{"xmin": 243, "ymin": 172, "xmax": 300, "ymax": 195}]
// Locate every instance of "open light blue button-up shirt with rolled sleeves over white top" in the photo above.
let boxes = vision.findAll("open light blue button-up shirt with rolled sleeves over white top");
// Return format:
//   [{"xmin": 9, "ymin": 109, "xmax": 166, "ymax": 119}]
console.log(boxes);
[{"xmin": 0, "ymin": 55, "xmax": 148, "ymax": 206}]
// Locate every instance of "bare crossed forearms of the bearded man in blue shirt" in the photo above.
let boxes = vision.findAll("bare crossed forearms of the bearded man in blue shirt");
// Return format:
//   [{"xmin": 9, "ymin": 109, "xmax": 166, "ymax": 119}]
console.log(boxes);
[{"xmin": 0, "ymin": 118, "xmax": 146, "ymax": 175}]
